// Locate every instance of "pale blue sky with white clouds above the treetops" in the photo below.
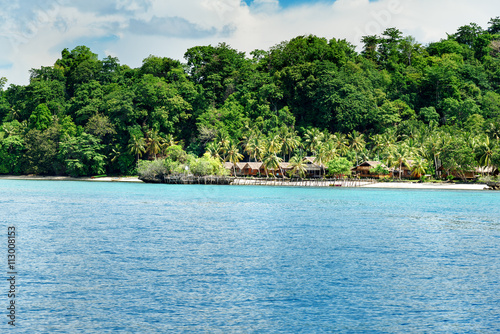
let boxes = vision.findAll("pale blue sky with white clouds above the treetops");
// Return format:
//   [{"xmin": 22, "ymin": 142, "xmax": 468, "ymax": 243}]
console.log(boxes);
[{"xmin": 0, "ymin": 0, "xmax": 500, "ymax": 85}]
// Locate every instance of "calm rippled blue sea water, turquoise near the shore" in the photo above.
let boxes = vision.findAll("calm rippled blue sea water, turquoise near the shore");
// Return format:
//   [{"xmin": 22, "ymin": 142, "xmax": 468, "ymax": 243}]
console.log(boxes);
[{"xmin": 0, "ymin": 181, "xmax": 500, "ymax": 333}]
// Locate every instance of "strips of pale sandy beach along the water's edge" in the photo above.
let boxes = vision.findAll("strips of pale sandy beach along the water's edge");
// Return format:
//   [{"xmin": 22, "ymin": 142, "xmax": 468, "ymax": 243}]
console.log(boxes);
[{"xmin": 0, "ymin": 175, "xmax": 488, "ymax": 191}]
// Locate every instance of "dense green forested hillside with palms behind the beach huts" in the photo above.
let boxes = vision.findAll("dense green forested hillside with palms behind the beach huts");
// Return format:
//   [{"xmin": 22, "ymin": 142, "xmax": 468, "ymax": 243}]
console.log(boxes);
[{"xmin": 0, "ymin": 17, "xmax": 500, "ymax": 176}]
